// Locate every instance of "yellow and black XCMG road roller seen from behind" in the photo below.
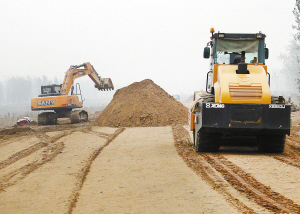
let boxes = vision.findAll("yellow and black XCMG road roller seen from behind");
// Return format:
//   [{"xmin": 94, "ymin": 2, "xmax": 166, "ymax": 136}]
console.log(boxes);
[{"xmin": 190, "ymin": 28, "xmax": 291, "ymax": 153}]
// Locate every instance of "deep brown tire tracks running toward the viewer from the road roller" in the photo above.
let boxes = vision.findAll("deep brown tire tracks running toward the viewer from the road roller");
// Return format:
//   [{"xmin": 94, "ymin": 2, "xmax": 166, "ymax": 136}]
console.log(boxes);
[{"xmin": 173, "ymin": 124, "xmax": 300, "ymax": 213}]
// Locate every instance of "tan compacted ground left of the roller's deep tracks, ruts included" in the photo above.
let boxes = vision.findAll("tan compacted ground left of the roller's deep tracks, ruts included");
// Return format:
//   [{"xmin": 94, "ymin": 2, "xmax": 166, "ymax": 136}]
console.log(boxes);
[{"xmin": 0, "ymin": 119, "xmax": 238, "ymax": 213}]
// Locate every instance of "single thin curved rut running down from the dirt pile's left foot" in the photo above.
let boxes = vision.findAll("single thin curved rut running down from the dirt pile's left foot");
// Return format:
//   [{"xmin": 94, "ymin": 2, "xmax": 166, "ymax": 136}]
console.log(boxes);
[{"xmin": 68, "ymin": 128, "xmax": 125, "ymax": 214}]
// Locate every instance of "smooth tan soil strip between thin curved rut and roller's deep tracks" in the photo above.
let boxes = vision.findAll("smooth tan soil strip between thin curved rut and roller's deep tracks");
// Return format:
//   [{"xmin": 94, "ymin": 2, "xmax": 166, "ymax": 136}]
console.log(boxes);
[{"xmin": 73, "ymin": 127, "xmax": 237, "ymax": 213}]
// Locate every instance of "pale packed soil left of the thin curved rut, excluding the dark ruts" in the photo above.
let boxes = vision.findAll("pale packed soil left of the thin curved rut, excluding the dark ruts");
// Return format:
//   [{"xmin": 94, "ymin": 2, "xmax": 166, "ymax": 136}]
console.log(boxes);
[{"xmin": 0, "ymin": 131, "xmax": 107, "ymax": 213}]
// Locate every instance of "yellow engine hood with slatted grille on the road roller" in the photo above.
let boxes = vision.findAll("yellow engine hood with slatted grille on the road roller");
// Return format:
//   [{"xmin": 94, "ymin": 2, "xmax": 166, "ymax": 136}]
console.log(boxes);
[{"xmin": 213, "ymin": 64, "xmax": 271, "ymax": 104}]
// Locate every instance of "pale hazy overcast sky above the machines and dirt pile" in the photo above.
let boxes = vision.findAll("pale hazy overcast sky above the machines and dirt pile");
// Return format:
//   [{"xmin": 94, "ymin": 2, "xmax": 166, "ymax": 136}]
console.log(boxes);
[{"xmin": 0, "ymin": 0, "xmax": 295, "ymax": 94}]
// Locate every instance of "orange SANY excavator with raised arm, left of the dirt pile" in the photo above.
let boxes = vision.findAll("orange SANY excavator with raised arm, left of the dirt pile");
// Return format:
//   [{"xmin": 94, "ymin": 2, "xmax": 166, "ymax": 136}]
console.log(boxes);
[{"xmin": 31, "ymin": 62, "xmax": 114, "ymax": 125}]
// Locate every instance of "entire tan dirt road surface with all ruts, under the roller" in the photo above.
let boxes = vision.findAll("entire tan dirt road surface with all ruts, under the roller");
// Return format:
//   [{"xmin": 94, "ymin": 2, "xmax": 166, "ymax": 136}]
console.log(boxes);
[{"xmin": 0, "ymin": 115, "xmax": 300, "ymax": 213}]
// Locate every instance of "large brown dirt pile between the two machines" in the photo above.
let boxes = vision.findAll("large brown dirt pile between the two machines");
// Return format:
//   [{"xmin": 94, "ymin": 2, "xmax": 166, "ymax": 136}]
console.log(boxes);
[{"xmin": 96, "ymin": 79, "xmax": 188, "ymax": 127}]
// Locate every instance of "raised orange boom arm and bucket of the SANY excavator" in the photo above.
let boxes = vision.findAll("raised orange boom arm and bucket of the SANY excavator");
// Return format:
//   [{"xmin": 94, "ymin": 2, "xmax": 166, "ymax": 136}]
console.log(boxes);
[{"xmin": 60, "ymin": 62, "xmax": 114, "ymax": 94}]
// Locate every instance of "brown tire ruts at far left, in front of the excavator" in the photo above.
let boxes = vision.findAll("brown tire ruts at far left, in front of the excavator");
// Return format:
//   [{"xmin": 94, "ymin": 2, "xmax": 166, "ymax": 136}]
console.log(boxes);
[{"xmin": 0, "ymin": 131, "xmax": 73, "ymax": 192}]
